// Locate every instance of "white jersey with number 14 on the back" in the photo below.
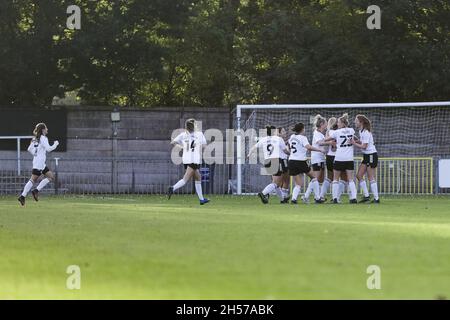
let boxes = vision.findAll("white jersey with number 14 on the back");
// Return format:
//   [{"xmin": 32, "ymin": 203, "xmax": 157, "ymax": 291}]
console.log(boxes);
[{"xmin": 173, "ymin": 131, "xmax": 206, "ymax": 164}]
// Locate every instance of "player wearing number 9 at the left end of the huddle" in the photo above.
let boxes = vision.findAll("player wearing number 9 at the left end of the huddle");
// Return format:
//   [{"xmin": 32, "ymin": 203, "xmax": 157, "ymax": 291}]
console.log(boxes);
[{"xmin": 247, "ymin": 126, "xmax": 289, "ymax": 204}]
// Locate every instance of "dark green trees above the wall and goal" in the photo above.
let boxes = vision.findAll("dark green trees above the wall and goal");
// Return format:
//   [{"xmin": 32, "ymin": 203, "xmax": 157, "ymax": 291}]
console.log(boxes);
[{"xmin": 0, "ymin": 0, "xmax": 450, "ymax": 107}]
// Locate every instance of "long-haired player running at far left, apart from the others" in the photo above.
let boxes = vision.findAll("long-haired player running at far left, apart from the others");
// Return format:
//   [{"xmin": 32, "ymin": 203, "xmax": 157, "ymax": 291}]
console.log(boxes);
[{"xmin": 18, "ymin": 123, "xmax": 59, "ymax": 206}]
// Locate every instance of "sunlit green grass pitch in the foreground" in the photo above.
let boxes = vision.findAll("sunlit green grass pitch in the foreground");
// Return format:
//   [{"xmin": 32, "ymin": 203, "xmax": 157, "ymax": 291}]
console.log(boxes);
[{"xmin": 0, "ymin": 196, "xmax": 450, "ymax": 299}]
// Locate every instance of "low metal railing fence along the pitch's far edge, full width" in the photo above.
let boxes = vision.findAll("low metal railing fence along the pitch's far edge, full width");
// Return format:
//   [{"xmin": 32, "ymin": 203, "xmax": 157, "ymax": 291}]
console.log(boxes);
[{"xmin": 0, "ymin": 158, "xmax": 450, "ymax": 195}]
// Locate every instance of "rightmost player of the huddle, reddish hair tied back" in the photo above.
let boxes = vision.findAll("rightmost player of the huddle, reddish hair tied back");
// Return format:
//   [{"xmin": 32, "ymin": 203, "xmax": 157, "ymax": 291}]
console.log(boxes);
[{"xmin": 353, "ymin": 114, "xmax": 380, "ymax": 203}]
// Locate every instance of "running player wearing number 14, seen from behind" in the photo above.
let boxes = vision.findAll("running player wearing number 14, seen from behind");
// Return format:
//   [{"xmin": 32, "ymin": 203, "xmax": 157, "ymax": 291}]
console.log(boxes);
[{"xmin": 167, "ymin": 119, "xmax": 210, "ymax": 205}]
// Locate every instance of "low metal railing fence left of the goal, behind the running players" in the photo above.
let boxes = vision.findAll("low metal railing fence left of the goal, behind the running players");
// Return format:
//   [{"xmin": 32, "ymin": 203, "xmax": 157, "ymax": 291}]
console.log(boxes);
[{"xmin": 0, "ymin": 159, "xmax": 230, "ymax": 194}]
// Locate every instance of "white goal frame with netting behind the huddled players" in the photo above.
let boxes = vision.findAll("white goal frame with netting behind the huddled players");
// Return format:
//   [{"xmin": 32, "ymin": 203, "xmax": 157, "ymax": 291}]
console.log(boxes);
[{"xmin": 235, "ymin": 101, "xmax": 450, "ymax": 195}]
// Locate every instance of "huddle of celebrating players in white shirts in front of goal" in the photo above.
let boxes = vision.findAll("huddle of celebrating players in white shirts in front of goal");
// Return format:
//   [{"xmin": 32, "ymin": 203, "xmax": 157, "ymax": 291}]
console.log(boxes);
[{"xmin": 247, "ymin": 114, "xmax": 380, "ymax": 204}]
